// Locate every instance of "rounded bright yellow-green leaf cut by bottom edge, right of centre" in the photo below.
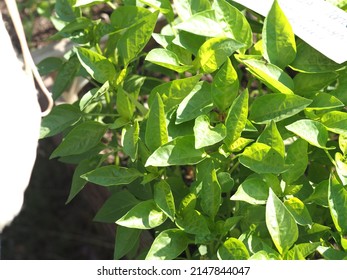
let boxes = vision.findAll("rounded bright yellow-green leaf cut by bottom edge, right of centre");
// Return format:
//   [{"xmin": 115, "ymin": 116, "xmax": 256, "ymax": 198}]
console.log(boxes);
[{"xmin": 217, "ymin": 237, "xmax": 249, "ymax": 260}]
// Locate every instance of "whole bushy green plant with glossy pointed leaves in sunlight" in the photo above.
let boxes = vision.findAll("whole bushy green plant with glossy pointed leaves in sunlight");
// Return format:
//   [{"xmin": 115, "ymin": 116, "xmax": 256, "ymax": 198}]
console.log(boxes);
[{"xmin": 39, "ymin": 0, "xmax": 347, "ymax": 260}]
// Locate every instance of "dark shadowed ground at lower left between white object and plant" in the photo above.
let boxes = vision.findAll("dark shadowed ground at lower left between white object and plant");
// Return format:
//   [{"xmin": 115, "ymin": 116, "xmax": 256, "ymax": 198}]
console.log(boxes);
[{"xmin": 1, "ymin": 139, "xmax": 114, "ymax": 260}]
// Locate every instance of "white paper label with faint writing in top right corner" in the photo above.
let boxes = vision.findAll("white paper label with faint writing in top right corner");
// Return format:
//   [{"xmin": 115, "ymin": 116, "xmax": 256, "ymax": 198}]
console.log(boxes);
[{"xmin": 234, "ymin": 0, "xmax": 347, "ymax": 63}]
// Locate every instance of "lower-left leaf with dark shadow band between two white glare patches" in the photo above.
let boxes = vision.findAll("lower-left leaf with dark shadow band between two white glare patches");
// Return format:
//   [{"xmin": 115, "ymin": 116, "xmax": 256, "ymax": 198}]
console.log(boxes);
[{"xmin": 116, "ymin": 199, "xmax": 167, "ymax": 229}]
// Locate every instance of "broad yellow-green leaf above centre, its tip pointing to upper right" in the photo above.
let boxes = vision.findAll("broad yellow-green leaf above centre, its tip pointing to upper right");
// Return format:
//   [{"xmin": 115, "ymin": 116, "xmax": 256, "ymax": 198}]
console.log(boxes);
[{"xmin": 148, "ymin": 75, "xmax": 202, "ymax": 112}]
